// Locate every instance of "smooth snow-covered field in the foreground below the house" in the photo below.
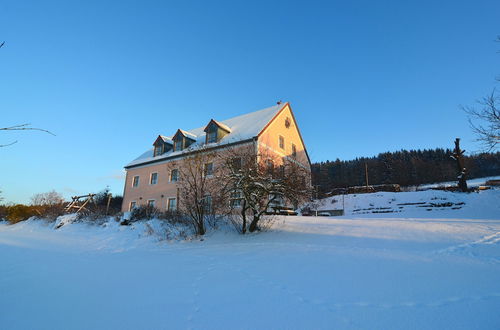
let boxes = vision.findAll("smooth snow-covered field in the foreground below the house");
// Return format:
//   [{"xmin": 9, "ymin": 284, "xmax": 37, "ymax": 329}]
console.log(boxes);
[{"xmin": 0, "ymin": 191, "xmax": 500, "ymax": 329}]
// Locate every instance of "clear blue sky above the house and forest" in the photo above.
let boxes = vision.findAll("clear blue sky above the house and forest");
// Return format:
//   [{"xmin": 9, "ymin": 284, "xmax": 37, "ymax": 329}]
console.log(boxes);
[{"xmin": 0, "ymin": 0, "xmax": 500, "ymax": 202}]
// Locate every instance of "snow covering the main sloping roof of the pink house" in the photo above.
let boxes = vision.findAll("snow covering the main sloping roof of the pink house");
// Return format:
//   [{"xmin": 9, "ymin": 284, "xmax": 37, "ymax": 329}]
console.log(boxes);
[{"xmin": 125, "ymin": 102, "xmax": 287, "ymax": 167}]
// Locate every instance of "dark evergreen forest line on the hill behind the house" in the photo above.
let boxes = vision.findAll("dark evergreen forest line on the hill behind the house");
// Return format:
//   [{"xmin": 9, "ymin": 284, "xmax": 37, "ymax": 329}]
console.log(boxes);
[{"xmin": 312, "ymin": 148, "xmax": 500, "ymax": 196}]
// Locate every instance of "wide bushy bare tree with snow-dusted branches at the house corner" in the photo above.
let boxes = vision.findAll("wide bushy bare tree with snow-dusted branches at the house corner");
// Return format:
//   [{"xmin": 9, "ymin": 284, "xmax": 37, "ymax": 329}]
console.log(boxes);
[{"xmin": 218, "ymin": 148, "xmax": 311, "ymax": 234}]
